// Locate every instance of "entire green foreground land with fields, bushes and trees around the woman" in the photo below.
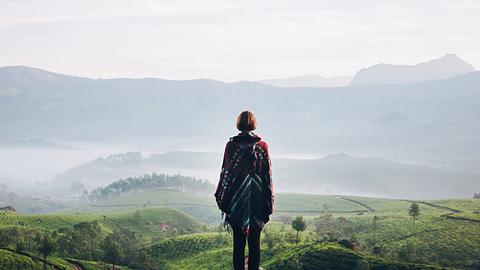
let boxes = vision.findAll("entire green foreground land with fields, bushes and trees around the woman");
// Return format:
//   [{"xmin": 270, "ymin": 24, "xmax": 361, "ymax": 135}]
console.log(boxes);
[{"xmin": 0, "ymin": 190, "xmax": 480, "ymax": 270}]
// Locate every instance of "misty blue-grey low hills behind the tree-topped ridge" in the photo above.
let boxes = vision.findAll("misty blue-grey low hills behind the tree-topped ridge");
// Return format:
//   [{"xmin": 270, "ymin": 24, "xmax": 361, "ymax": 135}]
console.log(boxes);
[{"xmin": 55, "ymin": 151, "xmax": 480, "ymax": 199}]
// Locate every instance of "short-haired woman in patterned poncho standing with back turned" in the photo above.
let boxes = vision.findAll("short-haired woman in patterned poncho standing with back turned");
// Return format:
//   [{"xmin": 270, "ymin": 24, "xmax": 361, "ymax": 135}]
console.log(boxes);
[{"xmin": 215, "ymin": 111, "xmax": 274, "ymax": 270}]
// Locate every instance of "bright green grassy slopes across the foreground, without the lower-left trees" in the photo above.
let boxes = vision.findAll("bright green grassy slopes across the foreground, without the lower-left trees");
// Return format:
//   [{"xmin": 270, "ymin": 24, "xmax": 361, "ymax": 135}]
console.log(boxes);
[{"xmin": 0, "ymin": 190, "xmax": 480, "ymax": 269}]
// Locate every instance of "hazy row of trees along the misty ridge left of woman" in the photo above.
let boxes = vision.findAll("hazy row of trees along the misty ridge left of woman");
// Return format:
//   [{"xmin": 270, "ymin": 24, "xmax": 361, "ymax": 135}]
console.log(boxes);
[{"xmin": 86, "ymin": 173, "xmax": 214, "ymax": 201}]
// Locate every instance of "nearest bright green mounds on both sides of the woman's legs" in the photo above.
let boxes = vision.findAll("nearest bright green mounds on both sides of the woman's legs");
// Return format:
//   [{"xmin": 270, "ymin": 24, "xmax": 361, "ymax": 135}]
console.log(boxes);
[{"xmin": 150, "ymin": 233, "xmax": 441, "ymax": 270}]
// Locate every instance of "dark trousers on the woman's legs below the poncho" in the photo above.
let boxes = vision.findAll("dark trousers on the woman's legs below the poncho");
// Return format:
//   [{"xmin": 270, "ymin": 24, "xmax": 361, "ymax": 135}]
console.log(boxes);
[{"xmin": 232, "ymin": 226, "xmax": 262, "ymax": 270}]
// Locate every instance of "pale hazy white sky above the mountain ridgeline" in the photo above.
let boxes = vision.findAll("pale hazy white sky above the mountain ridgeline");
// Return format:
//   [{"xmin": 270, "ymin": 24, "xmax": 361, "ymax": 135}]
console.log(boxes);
[{"xmin": 0, "ymin": 0, "xmax": 480, "ymax": 81}]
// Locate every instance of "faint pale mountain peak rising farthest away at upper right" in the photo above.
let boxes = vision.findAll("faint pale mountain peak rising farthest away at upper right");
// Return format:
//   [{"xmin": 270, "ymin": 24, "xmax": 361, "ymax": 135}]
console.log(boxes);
[{"xmin": 350, "ymin": 53, "xmax": 475, "ymax": 85}]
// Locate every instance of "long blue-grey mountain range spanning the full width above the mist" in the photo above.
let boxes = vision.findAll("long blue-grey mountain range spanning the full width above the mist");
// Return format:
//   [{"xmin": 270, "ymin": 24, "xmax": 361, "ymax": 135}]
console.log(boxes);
[{"xmin": 0, "ymin": 55, "xmax": 480, "ymax": 175}]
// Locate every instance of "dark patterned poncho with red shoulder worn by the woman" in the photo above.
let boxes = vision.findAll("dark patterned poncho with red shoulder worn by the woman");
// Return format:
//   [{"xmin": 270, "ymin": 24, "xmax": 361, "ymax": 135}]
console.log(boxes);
[{"xmin": 215, "ymin": 132, "xmax": 274, "ymax": 235}]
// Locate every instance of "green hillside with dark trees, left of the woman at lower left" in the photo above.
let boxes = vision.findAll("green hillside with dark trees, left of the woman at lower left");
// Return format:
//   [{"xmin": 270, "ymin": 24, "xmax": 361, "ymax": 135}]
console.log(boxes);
[{"xmin": 0, "ymin": 208, "xmax": 202, "ymax": 269}]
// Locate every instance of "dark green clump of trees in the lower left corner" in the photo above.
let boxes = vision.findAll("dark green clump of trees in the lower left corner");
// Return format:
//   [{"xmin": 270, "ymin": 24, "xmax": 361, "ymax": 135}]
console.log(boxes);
[{"xmin": 0, "ymin": 221, "xmax": 158, "ymax": 269}]
